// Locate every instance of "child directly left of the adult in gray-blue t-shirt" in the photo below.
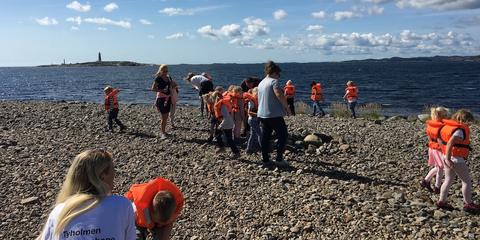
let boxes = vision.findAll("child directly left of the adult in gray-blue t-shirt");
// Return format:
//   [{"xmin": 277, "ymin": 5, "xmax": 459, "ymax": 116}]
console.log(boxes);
[{"xmin": 245, "ymin": 87, "xmax": 260, "ymax": 154}]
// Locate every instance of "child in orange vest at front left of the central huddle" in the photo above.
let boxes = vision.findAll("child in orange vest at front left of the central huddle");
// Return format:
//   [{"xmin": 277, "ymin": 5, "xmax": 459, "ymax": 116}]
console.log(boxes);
[{"xmin": 214, "ymin": 91, "xmax": 240, "ymax": 157}]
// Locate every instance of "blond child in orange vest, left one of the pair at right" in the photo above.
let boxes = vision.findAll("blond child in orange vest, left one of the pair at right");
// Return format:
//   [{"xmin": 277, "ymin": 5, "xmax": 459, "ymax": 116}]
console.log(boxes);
[{"xmin": 420, "ymin": 107, "xmax": 447, "ymax": 194}]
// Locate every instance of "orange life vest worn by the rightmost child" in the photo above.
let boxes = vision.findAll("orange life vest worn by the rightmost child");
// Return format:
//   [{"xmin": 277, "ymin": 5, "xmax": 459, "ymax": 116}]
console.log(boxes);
[{"xmin": 440, "ymin": 119, "xmax": 470, "ymax": 158}]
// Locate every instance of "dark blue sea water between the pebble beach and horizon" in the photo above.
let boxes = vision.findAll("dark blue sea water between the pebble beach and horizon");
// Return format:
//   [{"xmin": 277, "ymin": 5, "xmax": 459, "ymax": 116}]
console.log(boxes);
[{"xmin": 0, "ymin": 62, "xmax": 480, "ymax": 114}]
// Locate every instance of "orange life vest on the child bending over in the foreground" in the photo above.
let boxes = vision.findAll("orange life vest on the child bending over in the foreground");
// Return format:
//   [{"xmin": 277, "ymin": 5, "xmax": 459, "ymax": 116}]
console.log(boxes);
[{"xmin": 125, "ymin": 178, "xmax": 184, "ymax": 229}]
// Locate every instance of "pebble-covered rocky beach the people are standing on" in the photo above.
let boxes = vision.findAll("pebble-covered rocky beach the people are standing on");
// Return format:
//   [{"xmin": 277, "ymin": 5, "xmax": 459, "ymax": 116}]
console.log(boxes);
[{"xmin": 0, "ymin": 101, "xmax": 480, "ymax": 240}]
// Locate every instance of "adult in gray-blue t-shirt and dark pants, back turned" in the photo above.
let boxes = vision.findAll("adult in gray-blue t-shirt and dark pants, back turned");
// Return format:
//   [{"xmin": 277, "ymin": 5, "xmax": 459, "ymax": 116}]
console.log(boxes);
[{"xmin": 257, "ymin": 61, "xmax": 290, "ymax": 167}]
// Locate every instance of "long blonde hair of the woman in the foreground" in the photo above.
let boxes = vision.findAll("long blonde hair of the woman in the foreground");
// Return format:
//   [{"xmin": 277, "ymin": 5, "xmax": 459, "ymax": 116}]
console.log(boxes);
[{"xmin": 55, "ymin": 150, "xmax": 113, "ymax": 235}]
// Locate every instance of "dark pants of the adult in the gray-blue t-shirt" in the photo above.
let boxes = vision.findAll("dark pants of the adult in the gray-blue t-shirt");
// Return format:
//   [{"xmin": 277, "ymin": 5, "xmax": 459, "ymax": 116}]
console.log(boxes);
[{"xmin": 259, "ymin": 117, "xmax": 288, "ymax": 162}]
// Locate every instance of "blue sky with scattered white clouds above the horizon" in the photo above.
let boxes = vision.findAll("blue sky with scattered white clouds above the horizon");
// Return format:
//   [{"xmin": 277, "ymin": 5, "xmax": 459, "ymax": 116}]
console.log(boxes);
[{"xmin": 0, "ymin": 0, "xmax": 480, "ymax": 66}]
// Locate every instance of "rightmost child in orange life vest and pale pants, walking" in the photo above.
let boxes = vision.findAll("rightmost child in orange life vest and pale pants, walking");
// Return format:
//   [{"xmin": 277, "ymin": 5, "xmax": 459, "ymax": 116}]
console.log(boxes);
[{"xmin": 437, "ymin": 109, "xmax": 480, "ymax": 212}]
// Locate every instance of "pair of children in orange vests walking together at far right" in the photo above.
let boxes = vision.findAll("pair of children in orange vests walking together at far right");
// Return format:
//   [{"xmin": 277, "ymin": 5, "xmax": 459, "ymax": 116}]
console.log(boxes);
[{"xmin": 420, "ymin": 107, "xmax": 480, "ymax": 213}]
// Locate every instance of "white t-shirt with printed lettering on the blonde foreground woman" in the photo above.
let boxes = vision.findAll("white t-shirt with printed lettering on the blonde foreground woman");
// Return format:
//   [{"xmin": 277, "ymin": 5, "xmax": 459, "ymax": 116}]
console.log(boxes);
[{"xmin": 41, "ymin": 195, "xmax": 136, "ymax": 240}]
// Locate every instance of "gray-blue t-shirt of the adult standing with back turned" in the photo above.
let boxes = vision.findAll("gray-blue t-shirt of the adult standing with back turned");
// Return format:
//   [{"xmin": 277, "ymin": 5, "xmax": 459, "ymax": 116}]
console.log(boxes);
[{"xmin": 257, "ymin": 76, "xmax": 286, "ymax": 118}]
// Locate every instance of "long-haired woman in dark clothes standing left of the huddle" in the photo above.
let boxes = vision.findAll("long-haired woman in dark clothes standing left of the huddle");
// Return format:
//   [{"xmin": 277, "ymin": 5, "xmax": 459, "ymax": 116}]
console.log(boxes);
[{"xmin": 152, "ymin": 64, "xmax": 172, "ymax": 139}]
